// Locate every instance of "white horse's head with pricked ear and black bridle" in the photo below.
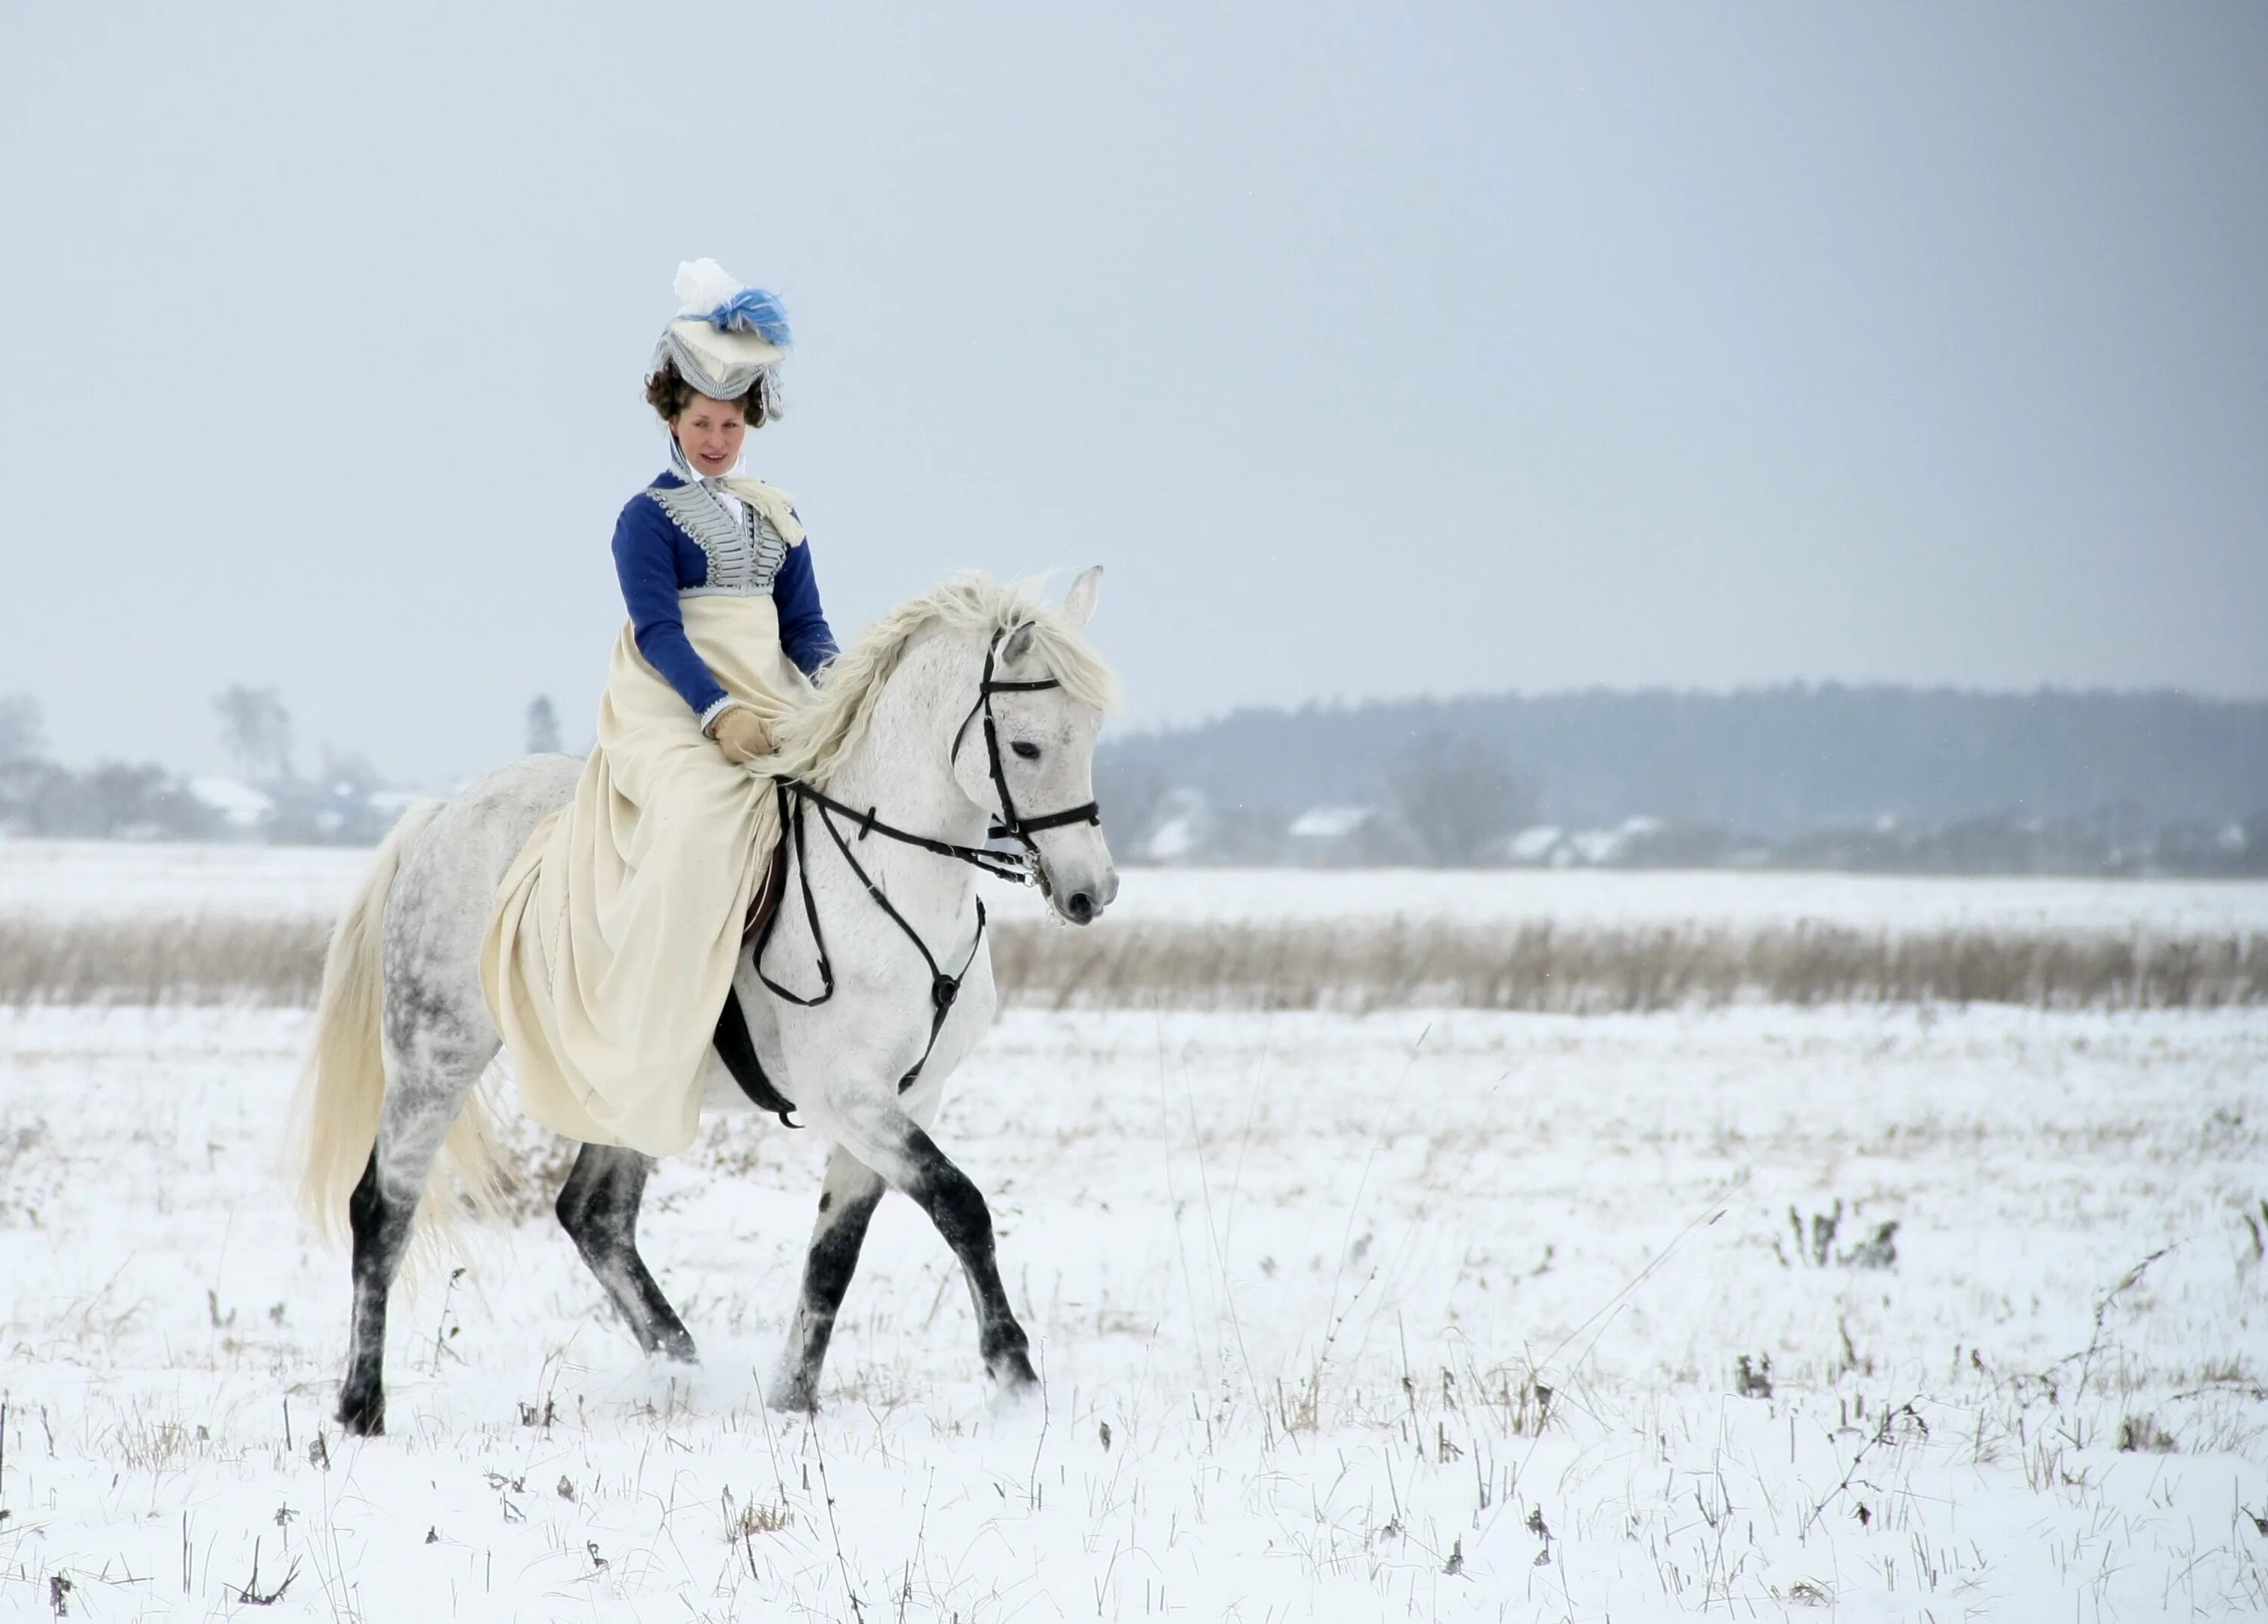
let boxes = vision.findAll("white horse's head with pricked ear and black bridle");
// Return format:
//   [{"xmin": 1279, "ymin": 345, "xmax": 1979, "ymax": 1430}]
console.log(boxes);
[{"xmin": 953, "ymin": 565, "xmax": 1118, "ymax": 925}]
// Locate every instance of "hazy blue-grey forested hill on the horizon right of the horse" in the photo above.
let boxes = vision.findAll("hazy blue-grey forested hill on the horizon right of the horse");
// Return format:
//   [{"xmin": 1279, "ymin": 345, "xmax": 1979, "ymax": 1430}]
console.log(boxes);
[{"xmin": 1100, "ymin": 683, "xmax": 2268, "ymax": 841}]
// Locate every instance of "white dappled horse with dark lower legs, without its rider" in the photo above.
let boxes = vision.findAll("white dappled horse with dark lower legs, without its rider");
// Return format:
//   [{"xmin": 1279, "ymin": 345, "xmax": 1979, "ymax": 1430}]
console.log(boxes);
[{"xmin": 297, "ymin": 569, "xmax": 1118, "ymax": 1433}]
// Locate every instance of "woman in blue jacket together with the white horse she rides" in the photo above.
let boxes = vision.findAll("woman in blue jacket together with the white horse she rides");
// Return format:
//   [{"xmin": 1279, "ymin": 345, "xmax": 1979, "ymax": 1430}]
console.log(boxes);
[{"xmin": 293, "ymin": 261, "xmax": 1118, "ymax": 1436}]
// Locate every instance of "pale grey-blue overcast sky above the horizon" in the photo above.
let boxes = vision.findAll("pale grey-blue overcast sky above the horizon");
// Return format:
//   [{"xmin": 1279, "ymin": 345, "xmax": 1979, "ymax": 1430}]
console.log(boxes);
[{"xmin": 0, "ymin": 0, "xmax": 2268, "ymax": 787}]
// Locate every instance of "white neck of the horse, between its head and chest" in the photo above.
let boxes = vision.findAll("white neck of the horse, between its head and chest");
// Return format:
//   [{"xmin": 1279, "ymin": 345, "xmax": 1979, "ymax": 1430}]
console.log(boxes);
[{"xmin": 812, "ymin": 637, "xmax": 989, "ymax": 928}]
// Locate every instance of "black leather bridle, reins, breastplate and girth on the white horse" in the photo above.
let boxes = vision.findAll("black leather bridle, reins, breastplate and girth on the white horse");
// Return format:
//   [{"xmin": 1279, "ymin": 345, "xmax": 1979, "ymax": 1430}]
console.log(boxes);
[{"xmin": 717, "ymin": 626, "xmax": 1102, "ymax": 1127}]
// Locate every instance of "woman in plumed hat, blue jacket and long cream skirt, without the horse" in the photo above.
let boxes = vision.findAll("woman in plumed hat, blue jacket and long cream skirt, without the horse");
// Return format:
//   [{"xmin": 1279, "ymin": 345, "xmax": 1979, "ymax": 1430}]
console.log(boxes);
[{"xmin": 481, "ymin": 259, "xmax": 835, "ymax": 1157}]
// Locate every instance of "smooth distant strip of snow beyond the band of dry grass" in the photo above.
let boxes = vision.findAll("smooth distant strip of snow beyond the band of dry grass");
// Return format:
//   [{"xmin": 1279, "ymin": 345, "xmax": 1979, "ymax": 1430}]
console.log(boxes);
[{"xmin": 13, "ymin": 839, "xmax": 2268, "ymax": 934}]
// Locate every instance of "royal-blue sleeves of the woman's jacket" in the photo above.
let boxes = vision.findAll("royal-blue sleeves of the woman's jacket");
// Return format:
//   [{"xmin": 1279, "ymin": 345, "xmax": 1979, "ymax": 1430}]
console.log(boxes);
[{"xmin": 615, "ymin": 472, "xmax": 837, "ymax": 714}]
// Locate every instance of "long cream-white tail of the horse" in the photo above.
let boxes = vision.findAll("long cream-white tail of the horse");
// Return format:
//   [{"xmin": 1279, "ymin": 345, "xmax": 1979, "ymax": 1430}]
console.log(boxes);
[{"xmin": 288, "ymin": 801, "xmax": 501, "ymax": 1241}]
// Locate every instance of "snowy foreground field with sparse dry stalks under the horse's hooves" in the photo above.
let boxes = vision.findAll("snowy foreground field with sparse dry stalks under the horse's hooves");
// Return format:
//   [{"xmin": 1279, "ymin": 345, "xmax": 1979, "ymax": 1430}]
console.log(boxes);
[{"xmin": 0, "ymin": 998, "xmax": 2268, "ymax": 1624}]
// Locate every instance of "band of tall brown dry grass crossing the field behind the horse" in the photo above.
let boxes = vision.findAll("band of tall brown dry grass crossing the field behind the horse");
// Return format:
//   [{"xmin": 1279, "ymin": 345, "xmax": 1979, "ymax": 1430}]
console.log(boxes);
[{"xmin": 0, "ymin": 919, "xmax": 2268, "ymax": 1014}]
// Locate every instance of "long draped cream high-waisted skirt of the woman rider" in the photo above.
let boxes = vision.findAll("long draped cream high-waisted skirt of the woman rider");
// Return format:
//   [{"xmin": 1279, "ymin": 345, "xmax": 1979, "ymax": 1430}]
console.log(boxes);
[{"xmin": 481, "ymin": 594, "xmax": 812, "ymax": 1157}]
